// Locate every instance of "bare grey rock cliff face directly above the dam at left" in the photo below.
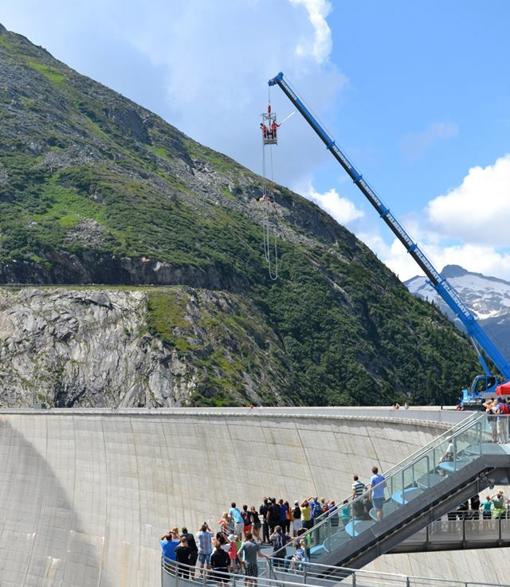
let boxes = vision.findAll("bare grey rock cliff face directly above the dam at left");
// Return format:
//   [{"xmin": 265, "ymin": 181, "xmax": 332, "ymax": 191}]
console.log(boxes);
[{"xmin": 0, "ymin": 288, "xmax": 285, "ymax": 407}]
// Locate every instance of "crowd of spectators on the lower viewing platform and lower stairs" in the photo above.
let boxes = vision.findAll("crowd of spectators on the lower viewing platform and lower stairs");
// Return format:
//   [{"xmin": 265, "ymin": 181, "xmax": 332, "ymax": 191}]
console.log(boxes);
[{"xmin": 160, "ymin": 467, "xmax": 385, "ymax": 582}]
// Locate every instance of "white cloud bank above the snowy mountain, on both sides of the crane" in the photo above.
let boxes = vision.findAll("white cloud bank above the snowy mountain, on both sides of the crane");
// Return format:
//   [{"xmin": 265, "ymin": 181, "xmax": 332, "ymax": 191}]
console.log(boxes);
[{"xmin": 357, "ymin": 154, "xmax": 510, "ymax": 280}]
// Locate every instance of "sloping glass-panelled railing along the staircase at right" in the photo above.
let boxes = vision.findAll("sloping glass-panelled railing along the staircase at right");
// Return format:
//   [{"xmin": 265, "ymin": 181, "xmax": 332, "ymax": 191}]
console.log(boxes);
[{"xmin": 282, "ymin": 413, "xmax": 510, "ymax": 562}]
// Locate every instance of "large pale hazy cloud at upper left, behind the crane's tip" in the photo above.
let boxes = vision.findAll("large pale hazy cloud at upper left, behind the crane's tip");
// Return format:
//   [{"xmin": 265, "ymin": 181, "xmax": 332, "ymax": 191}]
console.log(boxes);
[{"xmin": 2, "ymin": 0, "xmax": 346, "ymax": 184}]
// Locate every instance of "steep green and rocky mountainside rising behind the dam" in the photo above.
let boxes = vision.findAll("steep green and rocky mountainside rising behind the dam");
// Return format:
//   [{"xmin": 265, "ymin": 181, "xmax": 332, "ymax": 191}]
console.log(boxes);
[{"xmin": 0, "ymin": 24, "xmax": 476, "ymax": 405}]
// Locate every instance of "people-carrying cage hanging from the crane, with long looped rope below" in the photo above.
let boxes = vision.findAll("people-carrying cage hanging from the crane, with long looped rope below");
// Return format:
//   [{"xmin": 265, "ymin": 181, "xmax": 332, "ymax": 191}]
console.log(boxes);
[{"xmin": 259, "ymin": 90, "xmax": 279, "ymax": 281}]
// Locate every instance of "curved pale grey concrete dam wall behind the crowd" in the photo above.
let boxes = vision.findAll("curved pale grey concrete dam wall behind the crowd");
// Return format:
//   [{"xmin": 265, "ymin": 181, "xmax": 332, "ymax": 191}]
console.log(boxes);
[{"xmin": 0, "ymin": 407, "xmax": 508, "ymax": 587}]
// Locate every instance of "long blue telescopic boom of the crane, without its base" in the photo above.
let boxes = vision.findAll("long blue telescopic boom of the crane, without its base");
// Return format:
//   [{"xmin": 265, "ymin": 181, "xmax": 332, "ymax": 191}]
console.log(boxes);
[{"xmin": 268, "ymin": 73, "xmax": 510, "ymax": 379}]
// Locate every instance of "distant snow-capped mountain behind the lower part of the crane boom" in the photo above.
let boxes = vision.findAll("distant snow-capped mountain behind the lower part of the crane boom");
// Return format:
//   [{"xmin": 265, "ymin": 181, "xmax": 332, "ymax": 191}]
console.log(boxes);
[{"xmin": 405, "ymin": 265, "xmax": 510, "ymax": 360}]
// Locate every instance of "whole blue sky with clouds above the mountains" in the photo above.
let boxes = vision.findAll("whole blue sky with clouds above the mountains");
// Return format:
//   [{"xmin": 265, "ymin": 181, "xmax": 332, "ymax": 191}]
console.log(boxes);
[{"xmin": 0, "ymin": 0, "xmax": 510, "ymax": 280}]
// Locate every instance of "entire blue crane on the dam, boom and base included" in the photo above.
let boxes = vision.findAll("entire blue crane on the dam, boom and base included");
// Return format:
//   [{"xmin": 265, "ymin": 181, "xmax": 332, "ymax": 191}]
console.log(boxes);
[{"xmin": 268, "ymin": 72, "xmax": 510, "ymax": 407}]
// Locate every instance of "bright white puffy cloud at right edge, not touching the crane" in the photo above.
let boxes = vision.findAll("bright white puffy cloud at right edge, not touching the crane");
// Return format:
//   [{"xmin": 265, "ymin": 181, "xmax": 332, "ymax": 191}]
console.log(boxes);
[{"xmin": 427, "ymin": 154, "xmax": 510, "ymax": 247}]
